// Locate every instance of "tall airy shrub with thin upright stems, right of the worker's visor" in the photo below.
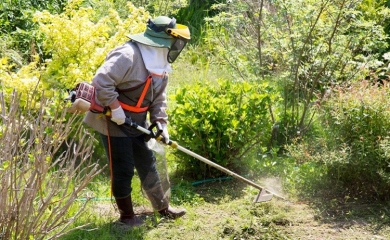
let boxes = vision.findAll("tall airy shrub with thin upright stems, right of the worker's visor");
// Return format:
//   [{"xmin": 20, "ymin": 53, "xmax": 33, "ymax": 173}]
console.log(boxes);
[{"xmin": 204, "ymin": 0, "xmax": 389, "ymax": 146}]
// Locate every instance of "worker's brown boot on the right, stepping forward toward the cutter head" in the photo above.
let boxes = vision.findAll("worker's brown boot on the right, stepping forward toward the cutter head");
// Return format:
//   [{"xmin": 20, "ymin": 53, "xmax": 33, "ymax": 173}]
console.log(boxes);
[{"xmin": 145, "ymin": 184, "xmax": 186, "ymax": 219}]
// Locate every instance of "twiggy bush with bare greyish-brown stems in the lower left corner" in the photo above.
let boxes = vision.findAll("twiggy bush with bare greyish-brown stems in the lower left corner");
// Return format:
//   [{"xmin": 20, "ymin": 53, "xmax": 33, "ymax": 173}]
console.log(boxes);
[{"xmin": 0, "ymin": 92, "xmax": 101, "ymax": 239}]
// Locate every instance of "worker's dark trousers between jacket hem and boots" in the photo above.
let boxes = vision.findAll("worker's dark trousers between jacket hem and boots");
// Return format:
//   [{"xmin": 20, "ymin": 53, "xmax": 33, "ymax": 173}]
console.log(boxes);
[{"xmin": 101, "ymin": 134, "xmax": 160, "ymax": 199}]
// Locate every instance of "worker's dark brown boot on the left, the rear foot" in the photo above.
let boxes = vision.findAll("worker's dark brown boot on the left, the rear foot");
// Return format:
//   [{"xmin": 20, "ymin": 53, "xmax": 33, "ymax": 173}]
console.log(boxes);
[{"xmin": 115, "ymin": 195, "xmax": 144, "ymax": 227}]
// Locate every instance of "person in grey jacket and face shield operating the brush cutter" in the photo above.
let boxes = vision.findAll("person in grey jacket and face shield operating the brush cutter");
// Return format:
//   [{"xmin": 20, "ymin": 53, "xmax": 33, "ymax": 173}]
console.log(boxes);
[{"xmin": 84, "ymin": 16, "xmax": 190, "ymax": 226}]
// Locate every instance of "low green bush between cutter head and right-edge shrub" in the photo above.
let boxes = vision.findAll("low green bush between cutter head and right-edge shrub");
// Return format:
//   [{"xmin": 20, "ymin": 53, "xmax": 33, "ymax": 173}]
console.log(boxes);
[{"xmin": 283, "ymin": 138, "xmax": 348, "ymax": 200}]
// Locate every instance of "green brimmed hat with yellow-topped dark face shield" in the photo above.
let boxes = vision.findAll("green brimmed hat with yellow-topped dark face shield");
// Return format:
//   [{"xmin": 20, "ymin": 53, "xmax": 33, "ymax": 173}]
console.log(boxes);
[{"xmin": 127, "ymin": 16, "xmax": 191, "ymax": 63}]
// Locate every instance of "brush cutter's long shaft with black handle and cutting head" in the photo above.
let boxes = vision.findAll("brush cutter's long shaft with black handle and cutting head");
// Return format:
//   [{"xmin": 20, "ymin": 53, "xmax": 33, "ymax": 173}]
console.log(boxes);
[{"xmin": 125, "ymin": 118, "xmax": 285, "ymax": 202}]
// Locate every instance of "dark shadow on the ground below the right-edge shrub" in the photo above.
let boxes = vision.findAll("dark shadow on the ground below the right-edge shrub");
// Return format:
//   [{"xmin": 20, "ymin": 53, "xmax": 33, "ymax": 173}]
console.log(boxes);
[{"xmin": 300, "ymin": 181, "xmax": 390, "ymax": 239}]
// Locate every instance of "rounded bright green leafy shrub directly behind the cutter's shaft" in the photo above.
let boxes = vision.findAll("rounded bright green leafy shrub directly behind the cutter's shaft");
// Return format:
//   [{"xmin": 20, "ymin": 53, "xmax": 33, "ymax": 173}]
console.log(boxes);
[{"xmin": 170, "ymin": 80, "xmax": 271, "ymax": 177}]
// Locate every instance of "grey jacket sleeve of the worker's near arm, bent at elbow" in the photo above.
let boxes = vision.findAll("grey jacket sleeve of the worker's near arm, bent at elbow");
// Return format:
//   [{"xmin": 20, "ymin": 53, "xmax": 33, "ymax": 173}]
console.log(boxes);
[{"xmin": 92, "ymin": 47, "xmax": 133, "ymax": 106}]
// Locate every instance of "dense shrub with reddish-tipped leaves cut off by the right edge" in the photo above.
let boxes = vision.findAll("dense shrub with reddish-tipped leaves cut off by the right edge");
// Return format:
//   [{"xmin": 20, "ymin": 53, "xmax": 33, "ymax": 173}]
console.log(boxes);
[{"xmin": 323, "ymin": 81, "xmax": 390, "ymax": 199}]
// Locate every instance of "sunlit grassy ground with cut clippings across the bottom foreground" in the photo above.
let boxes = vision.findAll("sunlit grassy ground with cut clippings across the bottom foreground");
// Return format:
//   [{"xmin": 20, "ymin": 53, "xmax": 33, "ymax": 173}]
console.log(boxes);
[{"xmin": 74, "ymin": 180, "xmax": 390, "ymax": 240}]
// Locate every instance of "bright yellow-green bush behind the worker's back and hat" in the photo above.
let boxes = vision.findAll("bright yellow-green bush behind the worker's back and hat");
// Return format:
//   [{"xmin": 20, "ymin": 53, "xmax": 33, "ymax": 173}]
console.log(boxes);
[{"xmin": 34, "ymin": 0, "xmax": 149, "ymax": 88}]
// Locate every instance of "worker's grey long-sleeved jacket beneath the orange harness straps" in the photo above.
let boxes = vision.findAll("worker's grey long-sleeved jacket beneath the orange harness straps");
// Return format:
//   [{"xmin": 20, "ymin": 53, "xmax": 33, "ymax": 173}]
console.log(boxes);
[{"xmin": 84, "ymin": 41, "xmax": 168, "ymax": 137}]
